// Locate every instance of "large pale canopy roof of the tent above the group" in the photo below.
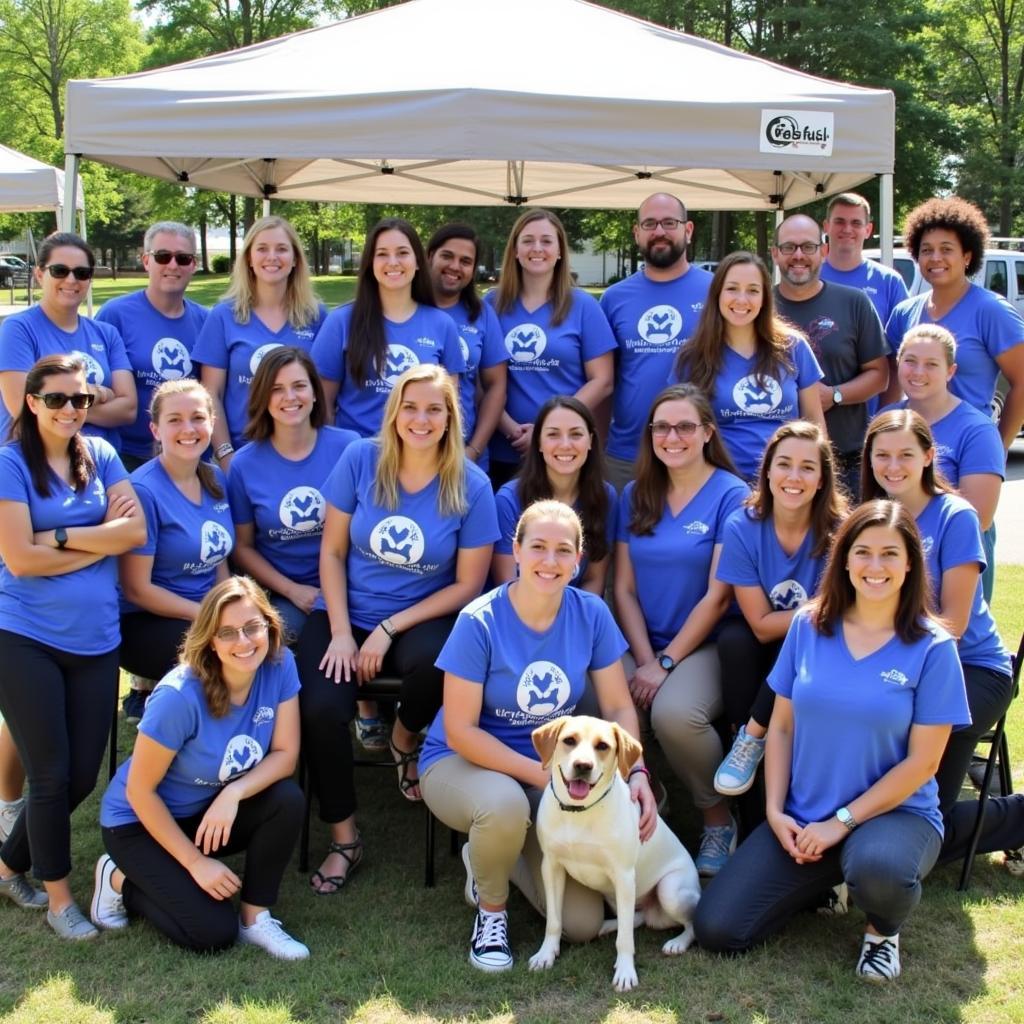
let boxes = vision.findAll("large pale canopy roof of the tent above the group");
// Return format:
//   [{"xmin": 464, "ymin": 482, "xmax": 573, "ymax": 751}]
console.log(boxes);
[{"xmin": 66, "ymin": 0, "xmax": 895, "ymax": 209}]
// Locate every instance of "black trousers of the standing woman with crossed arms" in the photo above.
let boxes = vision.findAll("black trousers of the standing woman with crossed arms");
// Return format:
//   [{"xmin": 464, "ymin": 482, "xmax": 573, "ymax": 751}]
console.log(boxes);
[{"xmin": 0, "ymin": 630, "xmax": 118, "ymax": 882}]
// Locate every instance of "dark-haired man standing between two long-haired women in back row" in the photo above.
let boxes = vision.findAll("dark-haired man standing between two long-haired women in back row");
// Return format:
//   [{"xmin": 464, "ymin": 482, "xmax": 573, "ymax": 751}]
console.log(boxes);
[{"xmin": 427, "ymin": 224, "xmax": 509, "ymax": 470}]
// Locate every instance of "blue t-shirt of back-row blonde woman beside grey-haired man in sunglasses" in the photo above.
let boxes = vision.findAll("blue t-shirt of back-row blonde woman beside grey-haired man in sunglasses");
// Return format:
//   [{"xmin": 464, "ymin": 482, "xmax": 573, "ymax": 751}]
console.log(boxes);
[{"xmin": 193, "ymin": 302, "xmax": 327, "ymax": 447}]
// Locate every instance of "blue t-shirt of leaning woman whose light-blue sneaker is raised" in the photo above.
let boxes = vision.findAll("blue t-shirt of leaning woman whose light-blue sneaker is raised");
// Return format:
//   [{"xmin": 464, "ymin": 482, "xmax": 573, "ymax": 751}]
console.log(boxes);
[{"xmin": 715, "ymin": 508, "xmax": 827, "ymax": 611}]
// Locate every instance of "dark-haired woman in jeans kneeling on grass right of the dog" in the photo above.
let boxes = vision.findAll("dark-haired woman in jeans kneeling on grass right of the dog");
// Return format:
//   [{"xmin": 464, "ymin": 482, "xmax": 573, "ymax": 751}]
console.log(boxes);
[{"xmin": 693, "ymin": 501, "xmax": 971, "ymax": 982}]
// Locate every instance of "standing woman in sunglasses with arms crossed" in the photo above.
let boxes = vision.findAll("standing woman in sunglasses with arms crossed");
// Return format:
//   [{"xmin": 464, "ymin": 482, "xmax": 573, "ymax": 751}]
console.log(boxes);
[{"xmin": 0, "ymin": 355, "xmax": 145, "ymax": 939}]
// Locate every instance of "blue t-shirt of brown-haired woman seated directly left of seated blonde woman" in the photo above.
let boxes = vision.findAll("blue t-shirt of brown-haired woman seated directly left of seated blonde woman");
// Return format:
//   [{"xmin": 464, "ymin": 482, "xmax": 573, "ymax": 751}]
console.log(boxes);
[{"xmin": 227, "ymin": 427, "xmax": 357, "ymax": 588}]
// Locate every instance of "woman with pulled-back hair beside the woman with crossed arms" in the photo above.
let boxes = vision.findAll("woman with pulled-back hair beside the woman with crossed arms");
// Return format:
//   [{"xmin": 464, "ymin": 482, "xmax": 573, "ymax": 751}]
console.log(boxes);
[{"xmin": 120, "ymin": 379, "xmax": 234, "ymax": 723}]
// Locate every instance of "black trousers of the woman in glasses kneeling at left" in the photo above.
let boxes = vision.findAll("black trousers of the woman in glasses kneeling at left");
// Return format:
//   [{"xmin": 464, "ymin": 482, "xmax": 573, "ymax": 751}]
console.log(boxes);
[{"xmin": 102, "ymin": 778, "xmax": 305, "ymax": 952}]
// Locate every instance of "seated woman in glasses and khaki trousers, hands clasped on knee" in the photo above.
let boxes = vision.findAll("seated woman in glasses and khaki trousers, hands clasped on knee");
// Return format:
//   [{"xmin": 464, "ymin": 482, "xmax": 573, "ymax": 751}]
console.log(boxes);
[{"xmin": 614, "ymin": 384, "xmax": 750, "ymax": 876}]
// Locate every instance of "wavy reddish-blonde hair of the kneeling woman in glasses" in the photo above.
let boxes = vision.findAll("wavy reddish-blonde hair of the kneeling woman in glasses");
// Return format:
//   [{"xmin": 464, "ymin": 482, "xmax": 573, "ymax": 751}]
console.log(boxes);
[{"xmin": 178, "ymin": 577, "xmax": 284, "ymax": 718}]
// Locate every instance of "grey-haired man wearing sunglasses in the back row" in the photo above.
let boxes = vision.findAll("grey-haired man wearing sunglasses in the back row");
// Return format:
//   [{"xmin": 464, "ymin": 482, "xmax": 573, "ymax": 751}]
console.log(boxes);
[{"xmin": 96, "ymin": 220, "xmax": 207, "ymax": 472}]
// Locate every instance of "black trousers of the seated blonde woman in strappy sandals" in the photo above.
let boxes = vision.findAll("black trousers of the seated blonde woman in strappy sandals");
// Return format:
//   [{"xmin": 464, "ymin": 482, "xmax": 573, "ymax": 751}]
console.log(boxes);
[{"xmin": 296, "ymin": 611, "xmax": 455, "ymax": 822}]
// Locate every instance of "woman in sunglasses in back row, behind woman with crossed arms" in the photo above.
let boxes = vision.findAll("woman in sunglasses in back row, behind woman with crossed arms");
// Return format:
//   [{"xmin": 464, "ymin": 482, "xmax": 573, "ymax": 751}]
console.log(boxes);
[{"xmin": 0, "ymin": 231, "xmax": 138, "ymax": 451}]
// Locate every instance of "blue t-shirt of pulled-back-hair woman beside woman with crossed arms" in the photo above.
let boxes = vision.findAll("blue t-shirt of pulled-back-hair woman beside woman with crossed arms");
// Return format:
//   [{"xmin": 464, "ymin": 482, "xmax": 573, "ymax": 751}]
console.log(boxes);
[{"xmin": 121, "ymin": 459, "xmax": 234, "ymax": 614}]
